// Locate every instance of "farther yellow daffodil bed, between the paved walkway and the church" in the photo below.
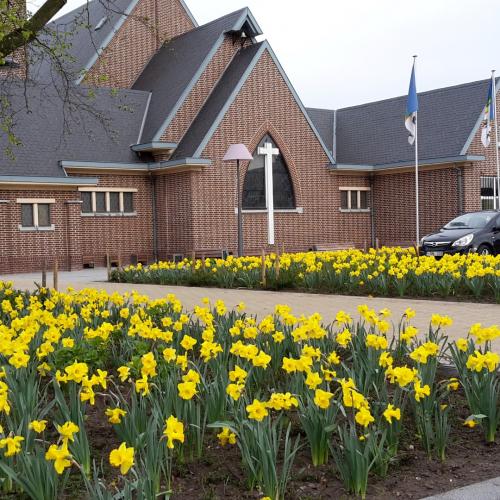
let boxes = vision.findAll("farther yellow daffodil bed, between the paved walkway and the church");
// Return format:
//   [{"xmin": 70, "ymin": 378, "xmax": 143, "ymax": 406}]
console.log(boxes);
[{"xmin": 111, "ymin": 248, "xmax": 500, "ymax": 302}]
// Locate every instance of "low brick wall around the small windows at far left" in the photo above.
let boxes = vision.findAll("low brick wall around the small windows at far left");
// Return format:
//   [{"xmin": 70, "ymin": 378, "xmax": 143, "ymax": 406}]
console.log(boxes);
[{"xmin": 0, "ymin": 175, "xmax": 153, "ymax": 273}]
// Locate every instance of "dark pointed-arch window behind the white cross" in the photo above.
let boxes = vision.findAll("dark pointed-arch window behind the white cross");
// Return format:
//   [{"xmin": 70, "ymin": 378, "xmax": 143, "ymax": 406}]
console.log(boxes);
[{"xmin": 242, "ymin": 134, "xmax": 295, "ymax": 210}]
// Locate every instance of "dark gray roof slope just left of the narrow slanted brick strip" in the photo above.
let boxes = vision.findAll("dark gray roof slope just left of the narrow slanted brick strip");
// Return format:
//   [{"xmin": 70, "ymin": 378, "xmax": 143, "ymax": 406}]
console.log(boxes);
[{"xmin": 133, "ymin": 9, "xmax": 248, "ymax": 142}]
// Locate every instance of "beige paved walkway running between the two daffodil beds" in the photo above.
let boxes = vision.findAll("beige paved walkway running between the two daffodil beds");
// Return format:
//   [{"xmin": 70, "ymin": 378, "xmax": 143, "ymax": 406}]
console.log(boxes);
[{"xmin": 0, "ymin": 269, "xmax": 500, "ymax": 352}]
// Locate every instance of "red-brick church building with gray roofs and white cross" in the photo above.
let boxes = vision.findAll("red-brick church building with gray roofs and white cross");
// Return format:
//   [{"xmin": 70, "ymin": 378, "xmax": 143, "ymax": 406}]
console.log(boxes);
[{"xmin": 0, "ymin": 0, "xmax": 500, "ymax": 273}]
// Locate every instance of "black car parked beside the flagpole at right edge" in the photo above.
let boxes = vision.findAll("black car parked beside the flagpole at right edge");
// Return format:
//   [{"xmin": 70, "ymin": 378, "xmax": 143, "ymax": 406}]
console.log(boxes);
[{"xmin": 420, "ymin": 210, "xmax": 500, "ymax": 257}]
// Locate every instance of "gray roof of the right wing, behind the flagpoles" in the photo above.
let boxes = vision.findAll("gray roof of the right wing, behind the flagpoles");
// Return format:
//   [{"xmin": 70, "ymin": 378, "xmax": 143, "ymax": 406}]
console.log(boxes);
[{"xmin": 308, "ymin": 80, "xmax": 496, "ymax": 166}]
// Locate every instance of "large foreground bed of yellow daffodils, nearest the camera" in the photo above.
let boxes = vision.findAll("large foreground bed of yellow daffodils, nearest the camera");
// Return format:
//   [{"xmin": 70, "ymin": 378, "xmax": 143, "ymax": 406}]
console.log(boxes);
[{"xmin": 0, "ymin": 285, "xmax": 500, "ymax": 500}]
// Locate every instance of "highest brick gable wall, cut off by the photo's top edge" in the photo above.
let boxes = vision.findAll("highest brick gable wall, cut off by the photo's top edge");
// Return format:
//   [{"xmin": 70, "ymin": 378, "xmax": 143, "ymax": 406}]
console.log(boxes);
[{"xmin": 85, "ymin": 0, "xmax": 194, "ymax": 88}]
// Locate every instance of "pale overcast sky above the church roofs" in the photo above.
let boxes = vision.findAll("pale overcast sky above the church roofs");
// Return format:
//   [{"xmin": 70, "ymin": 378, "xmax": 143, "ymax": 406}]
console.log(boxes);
[{"xmin": 28, "ymin": 0, "xmax": 500, "ymax": 109}]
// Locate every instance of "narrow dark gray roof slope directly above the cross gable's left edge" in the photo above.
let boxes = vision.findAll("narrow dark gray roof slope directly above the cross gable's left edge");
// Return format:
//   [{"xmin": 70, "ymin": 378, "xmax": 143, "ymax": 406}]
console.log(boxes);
[{"xmin": 172, "ymin": 42, "xmax": 265, "ymax": 160}]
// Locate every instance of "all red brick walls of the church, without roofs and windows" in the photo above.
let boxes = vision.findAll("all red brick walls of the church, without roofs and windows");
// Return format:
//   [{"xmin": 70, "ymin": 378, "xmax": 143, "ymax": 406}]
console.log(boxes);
[{"xmin": 0, "ymin": 0, "xmax": 500, "ymax": 273}]
